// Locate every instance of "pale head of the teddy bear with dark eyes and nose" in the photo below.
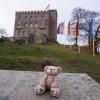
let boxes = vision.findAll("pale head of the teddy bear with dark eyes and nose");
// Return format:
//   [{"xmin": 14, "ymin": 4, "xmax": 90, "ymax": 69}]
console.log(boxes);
[{"xmin": 44, "ymin": 66, "xmax": 62, "ymax": 75}]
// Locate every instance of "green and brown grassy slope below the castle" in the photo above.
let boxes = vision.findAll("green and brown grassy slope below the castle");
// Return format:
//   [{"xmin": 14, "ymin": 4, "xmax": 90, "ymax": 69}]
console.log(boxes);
[{"xmin": 0, "ymin": 43, "xmax": 100, "ymax": 83}]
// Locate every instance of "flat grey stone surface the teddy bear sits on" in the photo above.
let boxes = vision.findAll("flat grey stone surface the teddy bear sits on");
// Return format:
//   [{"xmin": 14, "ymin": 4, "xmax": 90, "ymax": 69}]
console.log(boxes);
[{"xmin": 0, "ymin": 70, "xmax": 100, "ymax": 100}]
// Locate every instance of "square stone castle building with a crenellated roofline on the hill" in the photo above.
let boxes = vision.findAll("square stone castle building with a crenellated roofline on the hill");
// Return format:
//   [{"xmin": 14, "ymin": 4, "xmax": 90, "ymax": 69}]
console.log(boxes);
[{"xmin": 14, "ymin": 10, "xmax": 57, "ymax": 44}]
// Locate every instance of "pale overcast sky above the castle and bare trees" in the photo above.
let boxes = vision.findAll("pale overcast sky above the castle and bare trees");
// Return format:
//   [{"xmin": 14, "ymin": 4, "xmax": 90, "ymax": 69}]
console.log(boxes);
[{"xmin": 0, "ymin": 0, "xmax": 100, "ymax": 36}]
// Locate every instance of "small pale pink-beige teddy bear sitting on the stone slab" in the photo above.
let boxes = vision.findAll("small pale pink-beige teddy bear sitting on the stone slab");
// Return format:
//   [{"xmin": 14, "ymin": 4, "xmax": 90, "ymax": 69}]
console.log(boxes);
[{"xmin": 34, "ymin": 66, "xmax": 62, "ymax": 97}]
